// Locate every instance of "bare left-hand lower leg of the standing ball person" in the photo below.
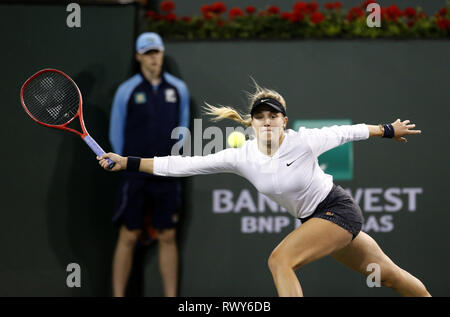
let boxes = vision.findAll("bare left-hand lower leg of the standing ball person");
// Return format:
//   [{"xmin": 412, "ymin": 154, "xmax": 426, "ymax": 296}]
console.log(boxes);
[{"xmin": 112, "ymin": 225, "xmax": 141, "ymax": 297}]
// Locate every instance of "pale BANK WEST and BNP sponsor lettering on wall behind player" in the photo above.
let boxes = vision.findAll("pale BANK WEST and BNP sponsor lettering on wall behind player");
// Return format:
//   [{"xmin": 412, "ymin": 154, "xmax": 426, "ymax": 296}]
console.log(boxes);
[{"xmin": 212, "ymin": 187, "xmax": 423, "ymax": 234}]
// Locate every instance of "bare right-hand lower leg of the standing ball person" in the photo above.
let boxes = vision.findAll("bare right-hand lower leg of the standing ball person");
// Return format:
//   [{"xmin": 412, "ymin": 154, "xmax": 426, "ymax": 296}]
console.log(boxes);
[{"xmin": 158, "ymin": 229, "xmax": 178, "ymax": 297}]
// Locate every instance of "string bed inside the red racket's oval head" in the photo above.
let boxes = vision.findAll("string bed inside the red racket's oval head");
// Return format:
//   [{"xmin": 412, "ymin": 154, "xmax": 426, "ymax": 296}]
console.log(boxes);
[{"xmin": 23, "ymin": 71, "xmax": 80, "ymax": 125}]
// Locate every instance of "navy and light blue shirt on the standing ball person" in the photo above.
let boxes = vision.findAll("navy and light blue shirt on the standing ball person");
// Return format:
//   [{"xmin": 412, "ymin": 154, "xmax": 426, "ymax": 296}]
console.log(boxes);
[{"xmin": 109, "ymin": 72, "xmax": 189, "ymax": 175}]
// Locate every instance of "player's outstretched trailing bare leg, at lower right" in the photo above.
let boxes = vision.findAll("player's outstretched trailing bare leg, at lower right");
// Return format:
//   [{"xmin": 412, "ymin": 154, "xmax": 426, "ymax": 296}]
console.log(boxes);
[{"xmin": 331, "ymin": 231, "xmax": 431, "ymax": 296}]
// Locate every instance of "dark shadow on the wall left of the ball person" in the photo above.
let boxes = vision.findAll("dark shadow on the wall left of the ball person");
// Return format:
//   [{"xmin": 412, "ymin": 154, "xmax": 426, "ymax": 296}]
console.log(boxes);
[{"xmin": 47, "ymin": 68, "xmax": 118, "ymax": 296}]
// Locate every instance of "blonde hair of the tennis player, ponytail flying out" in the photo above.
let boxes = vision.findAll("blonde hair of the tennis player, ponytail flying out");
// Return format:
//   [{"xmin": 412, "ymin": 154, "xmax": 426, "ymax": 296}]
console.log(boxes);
[{"xmin": 203, "ymin": 78, "xmax": 286, "ymax": 127}]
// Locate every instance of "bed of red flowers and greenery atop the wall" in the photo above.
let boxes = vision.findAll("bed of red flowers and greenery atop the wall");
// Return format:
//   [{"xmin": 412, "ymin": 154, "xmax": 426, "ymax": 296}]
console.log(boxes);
[{"xmin": 146, "ymin": 0, "xmax": 450, "ymax": 40}]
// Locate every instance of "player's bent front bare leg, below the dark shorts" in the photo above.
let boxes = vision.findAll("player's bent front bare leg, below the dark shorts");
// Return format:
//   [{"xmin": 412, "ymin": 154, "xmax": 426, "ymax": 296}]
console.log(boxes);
[{"xmin": 268, "ymin": 218, "xmax": 352, "ymax": 296}]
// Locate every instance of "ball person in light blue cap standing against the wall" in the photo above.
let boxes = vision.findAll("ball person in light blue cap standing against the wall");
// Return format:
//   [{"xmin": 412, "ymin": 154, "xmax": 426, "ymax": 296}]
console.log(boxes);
[{"xmin": 109, "ymin": 33, "xmax": 189, "ymax": 296}]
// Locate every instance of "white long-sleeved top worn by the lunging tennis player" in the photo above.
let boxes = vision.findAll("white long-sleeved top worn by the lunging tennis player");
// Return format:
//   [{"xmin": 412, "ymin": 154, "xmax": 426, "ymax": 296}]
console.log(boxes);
[{"xmin": 153, "ymin": 124, "xmax": 369, "ymax": 218}]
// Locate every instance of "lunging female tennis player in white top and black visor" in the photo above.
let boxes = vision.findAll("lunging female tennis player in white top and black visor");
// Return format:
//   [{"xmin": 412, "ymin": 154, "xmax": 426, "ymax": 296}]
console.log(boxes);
[{"xmin": 98, "ymin": 85, "xmax": 430, "ymax": 296}]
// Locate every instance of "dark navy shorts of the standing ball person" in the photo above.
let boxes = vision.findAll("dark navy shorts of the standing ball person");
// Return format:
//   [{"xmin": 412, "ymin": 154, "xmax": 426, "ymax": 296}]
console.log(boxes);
[{"xmin": 113, "ymin": 175, "xmax": 182, "ymax": 236}]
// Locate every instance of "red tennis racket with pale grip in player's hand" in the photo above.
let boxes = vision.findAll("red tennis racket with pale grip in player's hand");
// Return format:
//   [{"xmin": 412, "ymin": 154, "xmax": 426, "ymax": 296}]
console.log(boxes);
[{"xmin": 20, "ymin": 68, "xmax": 115, "ymax": 169}]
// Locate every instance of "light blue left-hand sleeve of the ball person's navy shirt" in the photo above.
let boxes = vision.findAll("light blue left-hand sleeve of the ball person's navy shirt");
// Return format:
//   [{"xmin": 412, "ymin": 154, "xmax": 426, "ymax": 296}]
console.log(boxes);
[{"xmin": 109, "ymin": 74, "xmax": 143, "ymax": 155}]
